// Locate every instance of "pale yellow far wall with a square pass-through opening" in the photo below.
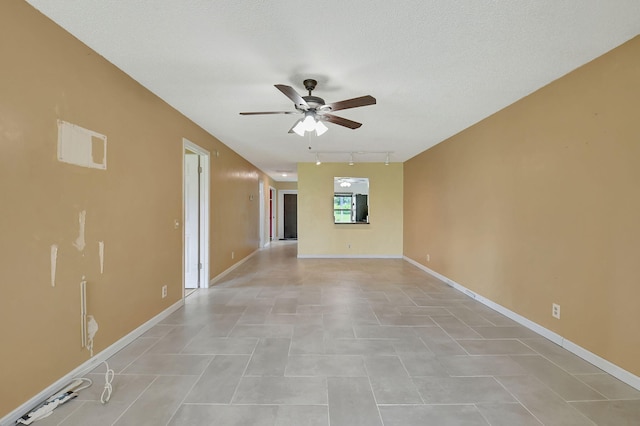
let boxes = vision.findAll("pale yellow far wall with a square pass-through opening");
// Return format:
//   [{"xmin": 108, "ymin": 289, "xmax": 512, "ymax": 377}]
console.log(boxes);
[{"xmin": 298, "ymin": 163, "xmax": 403, "ymax": 256}]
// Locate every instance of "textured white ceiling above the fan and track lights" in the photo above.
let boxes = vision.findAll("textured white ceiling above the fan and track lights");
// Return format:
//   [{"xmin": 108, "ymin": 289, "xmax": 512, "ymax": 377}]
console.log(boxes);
[{"xmin": 27, "ymin": 0, "xmax": 640, "ymax": 181}]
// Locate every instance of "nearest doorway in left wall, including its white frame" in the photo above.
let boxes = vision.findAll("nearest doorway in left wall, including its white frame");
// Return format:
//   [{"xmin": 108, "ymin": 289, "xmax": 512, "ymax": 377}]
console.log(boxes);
[{"xmin": 182, "ymin": 139, "xmax": 210, "ymax": 296}]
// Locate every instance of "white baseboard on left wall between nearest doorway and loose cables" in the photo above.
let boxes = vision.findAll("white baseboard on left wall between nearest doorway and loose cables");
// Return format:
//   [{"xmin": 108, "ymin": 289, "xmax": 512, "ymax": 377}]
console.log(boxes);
[{"xmin": 0, "ymin": 299, "xmax": 184, "ymax": 426}]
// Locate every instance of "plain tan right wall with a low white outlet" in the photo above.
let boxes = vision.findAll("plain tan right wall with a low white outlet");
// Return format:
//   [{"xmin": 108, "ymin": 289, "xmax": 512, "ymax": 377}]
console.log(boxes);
[{"xmin": 404, "ymin": 37, "xmax": 640, "ymax": 375}]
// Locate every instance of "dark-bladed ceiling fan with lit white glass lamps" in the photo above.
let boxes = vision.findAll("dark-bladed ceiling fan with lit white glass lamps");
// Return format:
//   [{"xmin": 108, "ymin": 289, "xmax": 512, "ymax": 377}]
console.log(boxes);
[{"xmin": 240, "ymin": 79, "xmax": 376, "ymax": 136}]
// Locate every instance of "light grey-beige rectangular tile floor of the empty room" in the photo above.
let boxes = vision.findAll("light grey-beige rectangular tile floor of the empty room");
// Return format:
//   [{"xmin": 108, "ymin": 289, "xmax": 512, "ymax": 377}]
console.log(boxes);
[{"xmin": 37, "ymin": 242, "xmax": 640, "ymax": 426}]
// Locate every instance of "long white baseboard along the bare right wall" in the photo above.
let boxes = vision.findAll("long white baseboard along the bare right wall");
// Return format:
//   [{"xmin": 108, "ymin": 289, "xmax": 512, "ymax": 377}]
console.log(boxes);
[{"xmin": 403, "ymin": 256, "xmax": 640, "ymax": 390}]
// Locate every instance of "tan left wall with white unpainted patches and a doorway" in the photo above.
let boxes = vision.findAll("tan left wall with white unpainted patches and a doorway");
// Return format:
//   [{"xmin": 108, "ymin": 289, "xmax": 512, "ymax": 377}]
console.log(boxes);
[{"xmin": 0, "ymin": 0, "xmax": 274, "ymax": 417}]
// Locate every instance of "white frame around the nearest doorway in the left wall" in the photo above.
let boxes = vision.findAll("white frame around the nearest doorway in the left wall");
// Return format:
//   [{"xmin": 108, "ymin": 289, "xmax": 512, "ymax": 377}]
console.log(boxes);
[{"xmin": 182, "ymin": 138, "xmax": 211, "ymax": 297}]
